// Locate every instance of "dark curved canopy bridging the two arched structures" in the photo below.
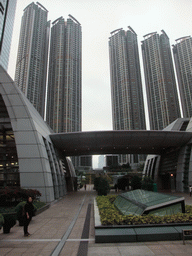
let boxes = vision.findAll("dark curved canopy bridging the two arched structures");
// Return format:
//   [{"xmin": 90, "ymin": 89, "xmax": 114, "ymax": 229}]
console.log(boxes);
[{"xmin": 50, "ymin": 130, "xmax": 192, "ymax": 156}]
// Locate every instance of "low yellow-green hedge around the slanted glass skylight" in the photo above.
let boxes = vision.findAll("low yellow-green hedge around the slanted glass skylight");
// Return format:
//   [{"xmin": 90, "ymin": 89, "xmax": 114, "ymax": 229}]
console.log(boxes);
[{"xmin": 96, "ymin": 195, "xmax": 192, "ymax": 225}]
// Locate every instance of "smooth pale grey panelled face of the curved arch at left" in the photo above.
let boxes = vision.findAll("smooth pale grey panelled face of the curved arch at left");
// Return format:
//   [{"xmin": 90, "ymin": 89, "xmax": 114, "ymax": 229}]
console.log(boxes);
[{"xmin": 0, "ymin": 67, "xmax": 66, "ymax": 202}]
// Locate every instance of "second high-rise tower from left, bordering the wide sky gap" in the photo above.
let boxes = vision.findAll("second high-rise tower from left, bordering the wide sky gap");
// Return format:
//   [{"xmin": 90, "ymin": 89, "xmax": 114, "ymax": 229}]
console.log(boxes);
[{"xmin": 46, "ymin": 15, "xmax": 82, "ymax": 132}]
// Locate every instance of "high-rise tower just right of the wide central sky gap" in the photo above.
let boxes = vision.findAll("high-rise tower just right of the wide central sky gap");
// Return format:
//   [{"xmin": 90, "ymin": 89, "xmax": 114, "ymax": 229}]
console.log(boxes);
[{"xmin": 109, "ymin": 27, "xmax": 146, "ymax": 163}]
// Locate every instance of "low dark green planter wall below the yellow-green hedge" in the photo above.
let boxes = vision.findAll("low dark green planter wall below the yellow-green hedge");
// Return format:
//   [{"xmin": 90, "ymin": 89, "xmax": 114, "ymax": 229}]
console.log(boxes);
[{"xmin": 94, "ymin": 200, "xmax": 192, "ymax": 243}]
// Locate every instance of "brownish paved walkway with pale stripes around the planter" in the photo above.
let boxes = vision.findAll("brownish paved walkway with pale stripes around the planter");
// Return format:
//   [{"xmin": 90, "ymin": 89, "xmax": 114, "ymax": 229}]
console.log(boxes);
[{"xmin": 0, "ymin": 185, "xmax": 192, "ymax": 256}]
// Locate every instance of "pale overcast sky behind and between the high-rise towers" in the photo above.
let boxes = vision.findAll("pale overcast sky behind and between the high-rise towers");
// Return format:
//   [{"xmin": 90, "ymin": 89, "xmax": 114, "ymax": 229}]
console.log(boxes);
[{"xmin": 8, "ymin": 0, "xmax": 192, "ymax": 166}]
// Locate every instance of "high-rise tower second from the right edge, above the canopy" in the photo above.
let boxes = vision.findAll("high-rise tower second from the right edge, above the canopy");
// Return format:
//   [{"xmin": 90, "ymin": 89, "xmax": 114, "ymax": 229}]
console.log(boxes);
[{"xmin": 142, "ymin": 30, "xmax": 181, "ymax": 130}]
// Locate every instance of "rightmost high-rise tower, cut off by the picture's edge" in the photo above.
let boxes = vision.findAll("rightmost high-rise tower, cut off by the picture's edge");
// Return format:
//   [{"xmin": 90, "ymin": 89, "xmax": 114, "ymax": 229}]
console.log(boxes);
[{"xmin": 173, "ymin": 36, "xmax": 192, "ymax": 117}]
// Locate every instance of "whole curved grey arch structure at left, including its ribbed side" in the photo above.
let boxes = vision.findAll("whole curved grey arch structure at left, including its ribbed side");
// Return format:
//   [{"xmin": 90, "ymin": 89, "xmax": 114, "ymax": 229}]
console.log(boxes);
[{"xmin": 0, "ymin": 66, "xmax": 75, "ymax": 202}]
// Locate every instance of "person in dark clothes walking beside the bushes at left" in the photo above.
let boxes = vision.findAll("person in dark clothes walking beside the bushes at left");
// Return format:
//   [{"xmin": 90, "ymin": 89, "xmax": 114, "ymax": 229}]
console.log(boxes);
[{"xmin": 24, "ymin": 196, "xmax": 34, "ymax": 236}]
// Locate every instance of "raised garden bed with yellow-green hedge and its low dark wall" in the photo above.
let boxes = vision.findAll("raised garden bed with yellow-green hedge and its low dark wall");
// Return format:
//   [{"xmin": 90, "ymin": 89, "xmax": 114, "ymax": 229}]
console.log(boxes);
[{"xmin": 95, "ymin": 195, "xmax": 192, "ymax": 243}]
